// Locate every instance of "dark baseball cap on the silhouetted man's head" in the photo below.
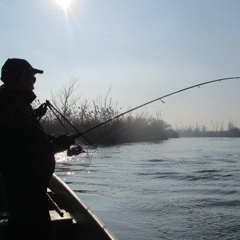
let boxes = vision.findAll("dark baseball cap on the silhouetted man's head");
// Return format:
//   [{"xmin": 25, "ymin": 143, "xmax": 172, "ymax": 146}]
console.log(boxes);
[{"xmin": 1, "ymin": 58, "xmax": 43, "ymax": 82}]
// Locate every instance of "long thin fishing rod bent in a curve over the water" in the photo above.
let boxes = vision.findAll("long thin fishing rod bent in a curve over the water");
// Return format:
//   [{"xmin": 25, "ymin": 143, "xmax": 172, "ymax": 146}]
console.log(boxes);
[{"xmin": 72, "ymin": 77, "xmax": 240, "ymax": 139}]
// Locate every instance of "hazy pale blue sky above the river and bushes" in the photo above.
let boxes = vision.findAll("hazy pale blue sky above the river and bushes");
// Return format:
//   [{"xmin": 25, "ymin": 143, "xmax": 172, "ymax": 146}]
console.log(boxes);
[{"xmin": 0, "ymin": 0, "xmax": 240, "ymax": 128}]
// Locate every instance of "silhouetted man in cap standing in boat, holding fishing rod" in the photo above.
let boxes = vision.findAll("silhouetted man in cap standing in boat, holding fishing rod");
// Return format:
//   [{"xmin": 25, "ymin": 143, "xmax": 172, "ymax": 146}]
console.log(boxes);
[{"xmin": 0, "ymin": 58, "xmax": 74, "ymax": 240}]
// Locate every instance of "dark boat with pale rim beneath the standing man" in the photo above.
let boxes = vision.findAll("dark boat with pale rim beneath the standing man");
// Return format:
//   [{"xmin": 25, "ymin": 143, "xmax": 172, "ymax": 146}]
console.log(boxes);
[{"xmin": 0, "ymin": 174, "xmax": 117, "ymax": 240}]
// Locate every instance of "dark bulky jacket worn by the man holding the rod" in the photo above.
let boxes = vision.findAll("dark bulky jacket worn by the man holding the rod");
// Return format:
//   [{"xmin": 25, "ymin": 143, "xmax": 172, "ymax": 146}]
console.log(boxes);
[{"xmin": 0, "ymin": 88, "xmax": 55, "ymax": 195}]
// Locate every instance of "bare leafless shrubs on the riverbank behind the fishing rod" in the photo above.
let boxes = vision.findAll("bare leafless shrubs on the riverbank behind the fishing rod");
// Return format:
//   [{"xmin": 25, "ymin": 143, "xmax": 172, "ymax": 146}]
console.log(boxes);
[{"xmin": 38, "ymin": 80, "xmax": 177, "ymax": 144}]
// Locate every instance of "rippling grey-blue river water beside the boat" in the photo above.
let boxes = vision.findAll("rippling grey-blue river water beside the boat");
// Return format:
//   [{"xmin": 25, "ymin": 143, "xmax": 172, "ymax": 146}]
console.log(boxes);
[{"xmin": 56, "ymin": 138, "xmax": 240, "ymax": 240}]
